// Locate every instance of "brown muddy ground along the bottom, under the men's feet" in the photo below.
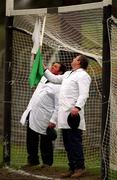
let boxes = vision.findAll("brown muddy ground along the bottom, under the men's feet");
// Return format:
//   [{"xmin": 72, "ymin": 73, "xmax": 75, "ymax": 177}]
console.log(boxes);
[{"xmin": 0, "ymin": 167, "xmax": 101, "ymax": 180}]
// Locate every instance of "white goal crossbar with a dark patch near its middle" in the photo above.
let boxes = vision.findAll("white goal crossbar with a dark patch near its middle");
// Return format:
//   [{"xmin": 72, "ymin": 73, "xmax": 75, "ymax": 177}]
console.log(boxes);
[{"xmin": 6, "ymin": 0, "xmax": 112, "ymax": 16}]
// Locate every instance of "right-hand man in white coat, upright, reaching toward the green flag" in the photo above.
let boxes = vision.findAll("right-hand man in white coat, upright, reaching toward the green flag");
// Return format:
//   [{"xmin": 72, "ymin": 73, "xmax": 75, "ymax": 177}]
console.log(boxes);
[{"xmin": 45, "ymin": 55, "xmax": 91, "ymax": 178}]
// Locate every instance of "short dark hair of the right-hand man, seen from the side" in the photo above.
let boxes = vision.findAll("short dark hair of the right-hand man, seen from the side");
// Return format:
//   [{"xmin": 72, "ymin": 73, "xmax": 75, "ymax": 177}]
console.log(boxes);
[{"xmin": 79, "ymin": 55, "xmax": 89, "ymax": 69}]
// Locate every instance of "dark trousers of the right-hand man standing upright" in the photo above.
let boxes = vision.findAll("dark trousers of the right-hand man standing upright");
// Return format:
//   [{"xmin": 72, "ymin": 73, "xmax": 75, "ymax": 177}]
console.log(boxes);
[{"xmin": 62, "ymin": 129, "xmax": 85, "ymax": 171}]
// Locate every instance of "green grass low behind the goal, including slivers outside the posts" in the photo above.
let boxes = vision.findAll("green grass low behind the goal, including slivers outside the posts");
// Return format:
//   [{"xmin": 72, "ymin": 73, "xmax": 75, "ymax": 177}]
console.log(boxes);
[{"xmin": 0, "ymin": 144, "xmax": 117, "ymax": 177}]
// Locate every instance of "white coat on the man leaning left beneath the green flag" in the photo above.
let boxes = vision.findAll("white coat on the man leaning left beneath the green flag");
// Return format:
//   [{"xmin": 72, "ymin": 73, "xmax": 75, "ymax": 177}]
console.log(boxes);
[{"xmin": 20, "ymin": 77, "xmax": 60, "ymax": 134}]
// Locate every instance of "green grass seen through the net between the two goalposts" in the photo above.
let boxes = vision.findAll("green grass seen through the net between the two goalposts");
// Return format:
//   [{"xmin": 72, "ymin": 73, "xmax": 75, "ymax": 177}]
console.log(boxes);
[{"xmin": 8, "ymin": 145, "xmax": 100, "ymax": 174}]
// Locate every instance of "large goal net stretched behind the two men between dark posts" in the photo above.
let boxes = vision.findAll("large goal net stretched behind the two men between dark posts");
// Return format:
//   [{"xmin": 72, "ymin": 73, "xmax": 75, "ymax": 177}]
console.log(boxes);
[{"xmin": 3, "ymin": 3, "xmax": 117, "ymax": 179}]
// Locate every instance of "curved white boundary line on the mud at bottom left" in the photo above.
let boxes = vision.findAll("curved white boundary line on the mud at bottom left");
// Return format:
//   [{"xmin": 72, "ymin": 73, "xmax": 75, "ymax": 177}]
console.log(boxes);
[{"xmin": 4, "ymin": 166, "xmax": 60, "ymax": 180}]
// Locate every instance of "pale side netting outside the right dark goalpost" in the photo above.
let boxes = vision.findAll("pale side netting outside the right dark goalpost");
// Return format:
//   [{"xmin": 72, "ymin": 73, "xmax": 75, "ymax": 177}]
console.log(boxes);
[{"xmin": 102, "ymin": 17, "xmax": 117, "ymax": 179}]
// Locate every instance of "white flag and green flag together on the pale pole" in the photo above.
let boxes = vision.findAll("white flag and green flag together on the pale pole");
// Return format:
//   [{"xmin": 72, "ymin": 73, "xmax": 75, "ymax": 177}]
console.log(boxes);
[{"xmin": 28, "ymin": 16, "xmax": 46, "ymax": 88}]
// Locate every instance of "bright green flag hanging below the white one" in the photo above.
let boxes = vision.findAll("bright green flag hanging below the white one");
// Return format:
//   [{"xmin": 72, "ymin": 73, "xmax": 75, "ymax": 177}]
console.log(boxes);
[{"xmin": 28, "ymin": 49, "xmax": 44, "ymax": 88}]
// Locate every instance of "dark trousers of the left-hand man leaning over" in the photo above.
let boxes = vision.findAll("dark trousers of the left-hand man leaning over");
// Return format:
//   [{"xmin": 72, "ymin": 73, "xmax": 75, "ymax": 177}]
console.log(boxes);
[{"xmin": 27, "ymin": 125, "xmax": 53, "ymax": 166}]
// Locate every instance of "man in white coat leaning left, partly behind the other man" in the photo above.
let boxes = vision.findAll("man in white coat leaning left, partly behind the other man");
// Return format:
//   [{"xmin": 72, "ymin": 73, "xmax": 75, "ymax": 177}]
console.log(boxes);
[{"xmin": 20, "ymin": 62, "xmax": 66, "ymax": 167}]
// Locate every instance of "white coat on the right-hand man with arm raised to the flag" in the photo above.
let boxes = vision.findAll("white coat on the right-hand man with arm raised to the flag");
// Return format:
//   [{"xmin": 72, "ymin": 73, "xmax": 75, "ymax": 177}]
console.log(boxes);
[{"xmin": 45, "ymin": 68, "xmax": 91, "ymax": 130}]
